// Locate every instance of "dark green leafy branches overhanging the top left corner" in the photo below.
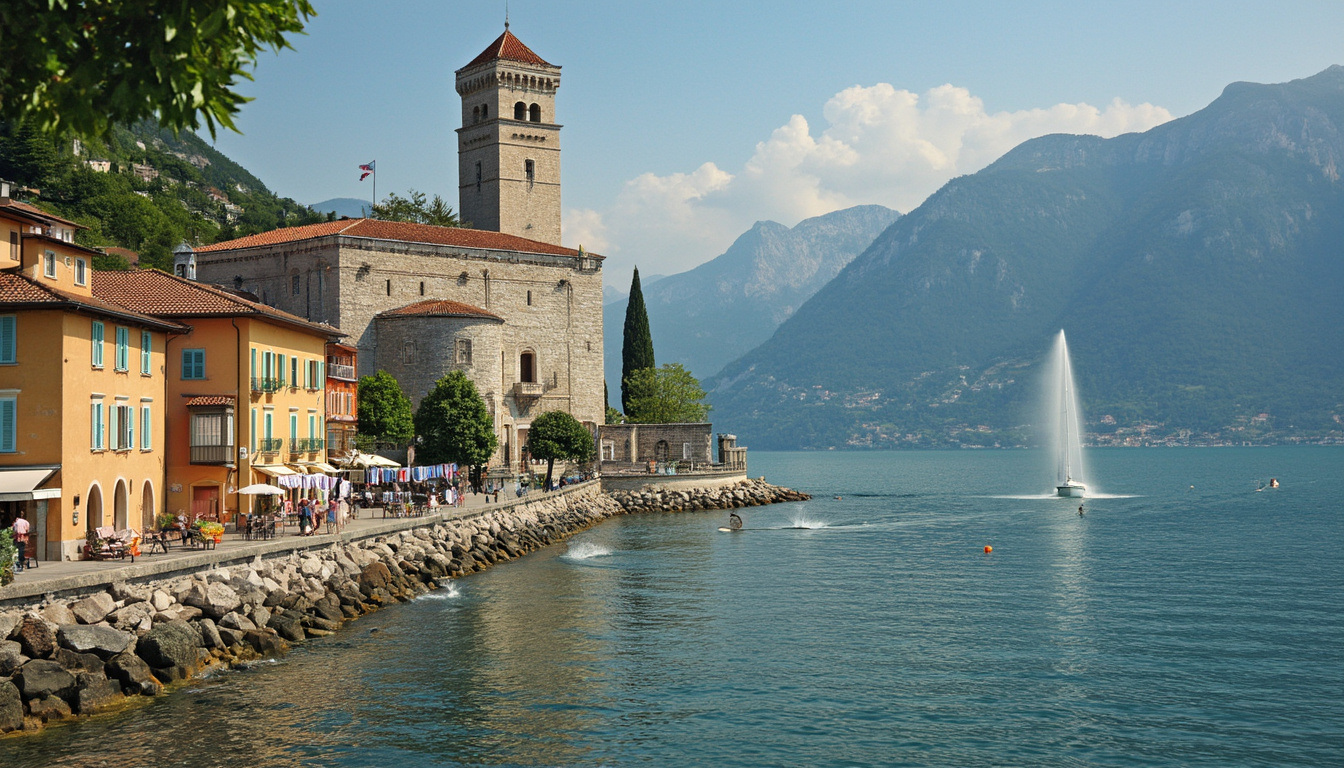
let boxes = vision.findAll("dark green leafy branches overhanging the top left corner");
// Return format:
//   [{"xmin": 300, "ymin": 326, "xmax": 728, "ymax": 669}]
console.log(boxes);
[{"xmin": 0, "ymin": 0, "xmax": 316, "ymax": 136}]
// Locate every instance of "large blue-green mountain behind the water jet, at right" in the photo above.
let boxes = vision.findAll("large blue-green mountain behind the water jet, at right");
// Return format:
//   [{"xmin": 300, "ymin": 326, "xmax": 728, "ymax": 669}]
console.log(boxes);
[{"xmin": 709, "ymin": 66, "xmax": 1344, "ymax": 448}]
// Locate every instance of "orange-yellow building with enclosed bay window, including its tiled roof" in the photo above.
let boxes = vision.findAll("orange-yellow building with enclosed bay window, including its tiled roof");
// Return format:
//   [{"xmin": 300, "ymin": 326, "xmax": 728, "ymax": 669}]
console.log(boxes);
[{"xmin": 94, "ymin": 270, "xmax": 343, "ymax": 523}]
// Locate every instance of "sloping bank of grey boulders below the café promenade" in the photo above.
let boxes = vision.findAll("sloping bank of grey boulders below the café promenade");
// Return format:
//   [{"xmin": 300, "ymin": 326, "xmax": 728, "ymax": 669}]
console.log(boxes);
[{"xmin": 0, "ymin": 487, "xmax": 625, "ymax": 732}]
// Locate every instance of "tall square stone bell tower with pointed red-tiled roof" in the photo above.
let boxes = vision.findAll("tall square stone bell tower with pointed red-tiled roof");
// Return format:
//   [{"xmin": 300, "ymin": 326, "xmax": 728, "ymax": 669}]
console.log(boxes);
[{"xmin": 457, "ymin": 22, "xmax": 560, "ymax": 245}]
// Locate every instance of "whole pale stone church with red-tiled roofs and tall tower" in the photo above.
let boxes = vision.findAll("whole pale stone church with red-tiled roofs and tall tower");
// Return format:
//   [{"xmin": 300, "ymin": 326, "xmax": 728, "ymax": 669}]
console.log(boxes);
[{"xmin": 195, "ymin": 28, "xmax": 605, "ymax": 467}]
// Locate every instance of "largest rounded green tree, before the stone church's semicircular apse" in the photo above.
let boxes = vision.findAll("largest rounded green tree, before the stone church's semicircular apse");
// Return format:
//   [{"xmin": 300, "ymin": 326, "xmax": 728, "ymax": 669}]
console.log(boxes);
[{"xmin": 415, "ymin": 371, "xmax": 497, "ymax": 488}]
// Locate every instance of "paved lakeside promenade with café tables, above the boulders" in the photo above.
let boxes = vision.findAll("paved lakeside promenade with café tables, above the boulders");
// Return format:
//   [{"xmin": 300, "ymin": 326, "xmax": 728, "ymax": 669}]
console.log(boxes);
[{"xmin": 0, "ymin": 480, "xmax": 599, "ymax": 608}]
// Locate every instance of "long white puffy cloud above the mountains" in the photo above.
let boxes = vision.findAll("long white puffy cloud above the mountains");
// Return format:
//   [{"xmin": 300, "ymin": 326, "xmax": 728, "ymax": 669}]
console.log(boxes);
[{"xmin": 564, "ymin": 83, "xmax": 1172, "ymax": 285}]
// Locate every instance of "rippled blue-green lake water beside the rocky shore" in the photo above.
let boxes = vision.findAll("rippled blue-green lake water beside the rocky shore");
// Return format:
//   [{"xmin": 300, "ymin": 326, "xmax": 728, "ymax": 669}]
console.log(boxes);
[{"xmin": 10, "ymin": 448, "xmax": 1344, "ymax": 768}]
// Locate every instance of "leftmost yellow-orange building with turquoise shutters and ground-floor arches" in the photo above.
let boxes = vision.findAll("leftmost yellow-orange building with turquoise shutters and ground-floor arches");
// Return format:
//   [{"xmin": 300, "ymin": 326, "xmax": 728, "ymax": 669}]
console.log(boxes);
[{"xmin": 0, "ymin": 196, "xmax": 187, "ymax": 560}]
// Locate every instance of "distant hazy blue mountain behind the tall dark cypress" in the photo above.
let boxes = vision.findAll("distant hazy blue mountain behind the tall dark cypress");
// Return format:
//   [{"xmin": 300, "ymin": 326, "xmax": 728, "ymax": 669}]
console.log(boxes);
[{"xmin": 603, "ymin": 206, "xmax": 899, "ymax": 400}]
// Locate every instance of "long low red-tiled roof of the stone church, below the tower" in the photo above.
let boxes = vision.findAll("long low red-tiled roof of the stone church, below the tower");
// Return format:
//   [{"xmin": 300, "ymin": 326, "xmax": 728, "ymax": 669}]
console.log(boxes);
[{"xmin": 196, "ymin": 219, "xmax": 602, "ymax": 258}]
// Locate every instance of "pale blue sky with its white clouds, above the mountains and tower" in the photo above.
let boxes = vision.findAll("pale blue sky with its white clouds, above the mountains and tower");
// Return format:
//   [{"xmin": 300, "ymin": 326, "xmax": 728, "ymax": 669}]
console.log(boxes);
[{"xmin": 209, "ymin": 0, "xmax": 1344, "ymax": 285}]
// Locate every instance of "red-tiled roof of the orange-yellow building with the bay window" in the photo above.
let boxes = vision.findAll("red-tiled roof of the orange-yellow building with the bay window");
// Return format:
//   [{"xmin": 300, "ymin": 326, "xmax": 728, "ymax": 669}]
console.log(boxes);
[{"xmin": 93, "ymin": 269, "xmax": 344, "ymax": 336}]
